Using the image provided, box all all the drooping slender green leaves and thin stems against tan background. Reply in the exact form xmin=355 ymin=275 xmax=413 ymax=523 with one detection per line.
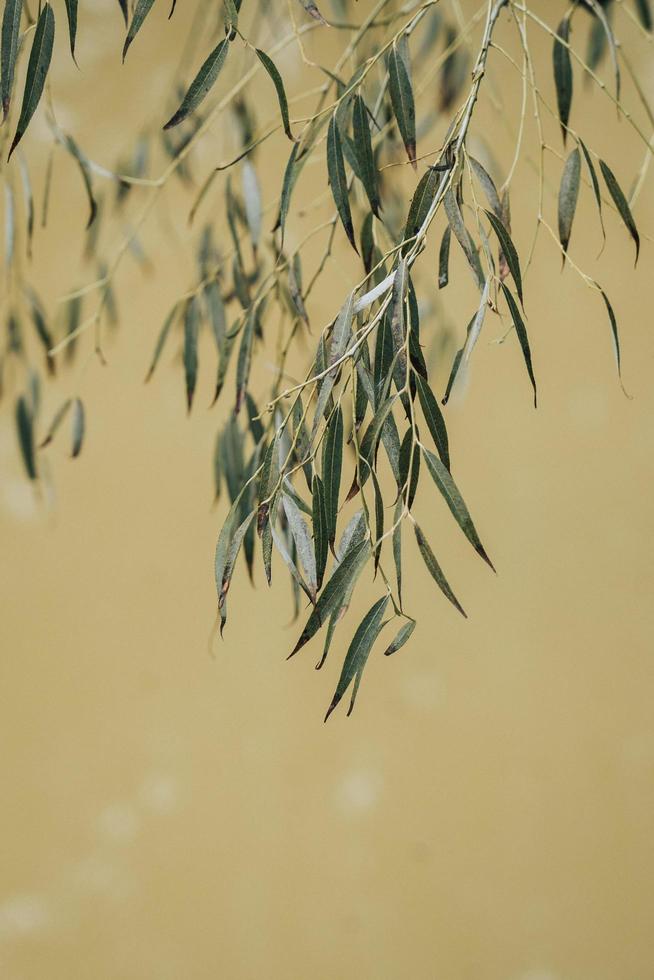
xmin=1 ymin=0 xmax=654 ymax=715
